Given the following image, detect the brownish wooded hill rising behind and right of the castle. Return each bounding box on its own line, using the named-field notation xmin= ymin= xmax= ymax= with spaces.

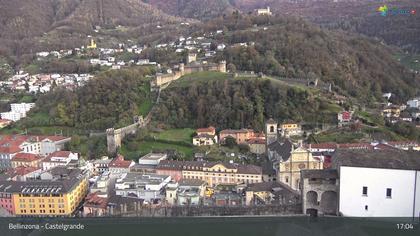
xmin=204 ymin=14 xmax=420 ymax=102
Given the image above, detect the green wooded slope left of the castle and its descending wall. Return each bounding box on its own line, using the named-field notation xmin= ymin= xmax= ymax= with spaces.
xmin=19 ymin=69 xmax=151 ymax=130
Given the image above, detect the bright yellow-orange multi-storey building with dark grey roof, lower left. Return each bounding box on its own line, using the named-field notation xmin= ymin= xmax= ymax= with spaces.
xmin=12 ymin=167 xmax=88 ymax=216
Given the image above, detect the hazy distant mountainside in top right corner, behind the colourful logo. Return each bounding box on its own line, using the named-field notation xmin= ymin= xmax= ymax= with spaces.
xmin=232 ymin=0 xmax=420 ymax=52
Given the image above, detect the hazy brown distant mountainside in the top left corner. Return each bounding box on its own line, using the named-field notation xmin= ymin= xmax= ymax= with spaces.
xmin=0 ymin=0 xmax=181 ymax=58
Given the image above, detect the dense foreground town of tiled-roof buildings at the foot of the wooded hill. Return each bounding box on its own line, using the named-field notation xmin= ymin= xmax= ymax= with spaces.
xmin=0 ymin=113 xmax=420 ymax=217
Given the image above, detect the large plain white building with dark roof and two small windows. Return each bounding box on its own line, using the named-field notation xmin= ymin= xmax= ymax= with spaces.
xmin=333 ymin=150 xmax=420 ymax=217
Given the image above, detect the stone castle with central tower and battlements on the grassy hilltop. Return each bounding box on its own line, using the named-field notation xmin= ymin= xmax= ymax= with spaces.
xmin=152 ymin=53 xmax=226 ymax=87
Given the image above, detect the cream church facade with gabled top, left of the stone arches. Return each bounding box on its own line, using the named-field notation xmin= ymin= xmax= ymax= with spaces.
xmin=279 ymin=147 xmax=323 ymax=190
